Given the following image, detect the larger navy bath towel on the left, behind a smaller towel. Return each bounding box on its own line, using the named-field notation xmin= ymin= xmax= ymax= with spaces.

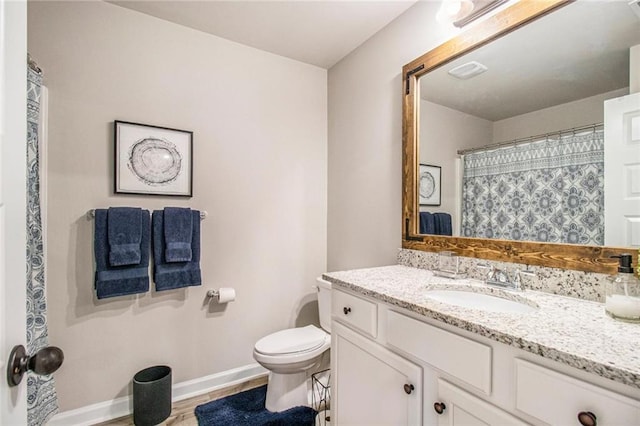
xmin=93 ymin=209 xmax=151 ymax=299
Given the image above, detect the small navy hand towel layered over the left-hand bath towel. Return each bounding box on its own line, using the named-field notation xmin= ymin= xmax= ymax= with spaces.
xmin=107 ymin=207 xmax=142 ymax=266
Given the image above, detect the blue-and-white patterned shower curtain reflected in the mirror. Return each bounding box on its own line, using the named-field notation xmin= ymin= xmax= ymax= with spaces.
xmin=462 ymin=129 xmax=604 ymax=245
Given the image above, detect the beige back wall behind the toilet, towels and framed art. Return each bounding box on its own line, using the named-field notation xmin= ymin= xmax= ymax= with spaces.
xmin=28 ymin=2 xmax=327 ymax=411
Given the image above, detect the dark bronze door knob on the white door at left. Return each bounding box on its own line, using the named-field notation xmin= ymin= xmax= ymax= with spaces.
xmin=7 ymin=345 xmax=64 ymax=386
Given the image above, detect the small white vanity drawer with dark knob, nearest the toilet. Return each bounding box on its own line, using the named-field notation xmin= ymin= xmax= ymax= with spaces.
xmin=331 ymin=290 xmax=378 ymax=337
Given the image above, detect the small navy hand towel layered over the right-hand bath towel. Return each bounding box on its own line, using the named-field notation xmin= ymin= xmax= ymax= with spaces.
xmin=164 ymin=207 xmax=192 ymax=262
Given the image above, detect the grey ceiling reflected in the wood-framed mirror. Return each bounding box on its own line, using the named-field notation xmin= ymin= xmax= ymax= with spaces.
xmin=420 ymin=1 xmax=640 ymax=121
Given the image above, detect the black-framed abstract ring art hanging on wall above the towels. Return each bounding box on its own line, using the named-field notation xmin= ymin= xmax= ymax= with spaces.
xmin=113 ymin=120 xmax=193 ymax=197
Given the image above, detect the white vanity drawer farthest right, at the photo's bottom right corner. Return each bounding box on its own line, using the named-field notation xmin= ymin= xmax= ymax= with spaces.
xmin=515 ymin=359 xmax=640 ymax=426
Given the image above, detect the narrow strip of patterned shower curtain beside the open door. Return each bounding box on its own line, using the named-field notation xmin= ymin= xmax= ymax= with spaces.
xmin=26 ymin=58 xmax=58 ymax=425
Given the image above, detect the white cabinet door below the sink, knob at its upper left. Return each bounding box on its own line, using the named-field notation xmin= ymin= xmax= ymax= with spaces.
xmin=434 ymin=379 xmax=527 ymax=426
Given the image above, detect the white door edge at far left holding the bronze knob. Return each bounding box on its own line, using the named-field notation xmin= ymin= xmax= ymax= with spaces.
xmin=0 ymin=0 xmax=27 ymax=425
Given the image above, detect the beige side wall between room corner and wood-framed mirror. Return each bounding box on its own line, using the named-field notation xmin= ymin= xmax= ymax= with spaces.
xmin=327 ymin=2 xmax=458 ymax=271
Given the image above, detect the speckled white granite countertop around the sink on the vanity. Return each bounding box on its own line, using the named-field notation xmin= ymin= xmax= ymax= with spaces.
xmin=323 ymin=265 xmax=640 ymax=388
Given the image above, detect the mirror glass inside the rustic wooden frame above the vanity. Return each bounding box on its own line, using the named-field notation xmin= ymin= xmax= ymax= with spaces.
xmin=418 ymin=2 xmax=640 ymax=247
